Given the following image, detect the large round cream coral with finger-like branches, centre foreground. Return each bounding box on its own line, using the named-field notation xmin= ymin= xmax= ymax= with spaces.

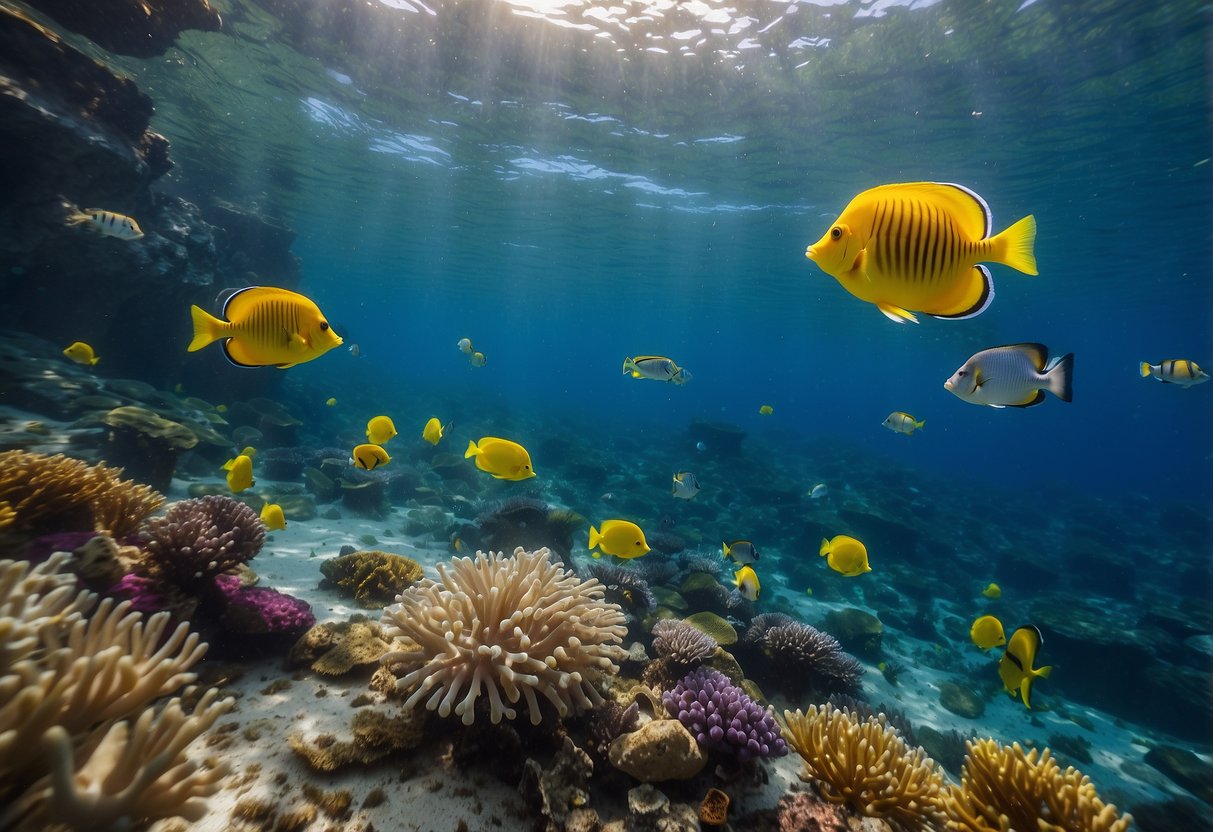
xmin=381 ymin=547 xmax=627 ymax=725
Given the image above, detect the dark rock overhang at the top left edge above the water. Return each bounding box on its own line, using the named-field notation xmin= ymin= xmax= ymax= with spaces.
xmin=29 ymin=0 xmax=222 ymax=58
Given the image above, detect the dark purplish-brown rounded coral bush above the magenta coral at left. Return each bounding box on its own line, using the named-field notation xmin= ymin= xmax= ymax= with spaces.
xmin=141 ymin=495 xmax=266 ymax=594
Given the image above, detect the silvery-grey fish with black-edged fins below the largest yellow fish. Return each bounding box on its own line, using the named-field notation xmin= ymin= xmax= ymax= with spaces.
xmin=944 ymin=343 xmax=1074 ymax=408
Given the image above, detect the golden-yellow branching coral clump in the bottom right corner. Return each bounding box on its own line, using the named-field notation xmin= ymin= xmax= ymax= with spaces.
xmin=939 ymin=739 xmax=1133 ymax=832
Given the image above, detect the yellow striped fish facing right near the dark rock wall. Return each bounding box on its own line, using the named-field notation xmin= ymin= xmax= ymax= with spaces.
xmin=189 ymin=286 xmax=341 ymax=369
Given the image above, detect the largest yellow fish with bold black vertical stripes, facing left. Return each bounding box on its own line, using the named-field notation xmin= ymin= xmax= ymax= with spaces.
xmin=804 ymin=182 xmax=1036 ymax=324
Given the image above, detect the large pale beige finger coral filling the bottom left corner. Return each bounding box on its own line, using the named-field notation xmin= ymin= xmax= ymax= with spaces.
xmin=0 ymin=553 xmax=234 ymax=831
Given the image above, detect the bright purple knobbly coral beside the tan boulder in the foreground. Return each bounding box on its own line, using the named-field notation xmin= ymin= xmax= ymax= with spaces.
xmin=661 ymin=667 xmax=787 ymax=762
